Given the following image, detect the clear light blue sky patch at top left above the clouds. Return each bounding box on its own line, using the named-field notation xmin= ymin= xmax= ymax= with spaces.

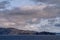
xmin=1 ymin=0 xmax=35 ymax=8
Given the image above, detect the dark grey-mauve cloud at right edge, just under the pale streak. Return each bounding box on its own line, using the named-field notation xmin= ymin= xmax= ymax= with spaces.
xmin=43 ymin=7 xmax=60 ymax=16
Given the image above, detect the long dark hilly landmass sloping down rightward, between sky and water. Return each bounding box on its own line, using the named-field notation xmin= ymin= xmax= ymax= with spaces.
xmin=0 ymin=28 xmax=56 ymax=35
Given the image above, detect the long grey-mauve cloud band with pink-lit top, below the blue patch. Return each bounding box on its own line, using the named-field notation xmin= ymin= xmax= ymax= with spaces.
xmin=4 ymin=5 xmax=60 ymax=18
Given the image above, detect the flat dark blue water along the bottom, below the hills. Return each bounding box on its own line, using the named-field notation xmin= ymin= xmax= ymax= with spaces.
xmin=0 ymin=35 xmax=60 ymax=40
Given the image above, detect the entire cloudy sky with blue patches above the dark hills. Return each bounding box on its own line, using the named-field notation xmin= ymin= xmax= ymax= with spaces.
xmin=0 ymin=0 xmax=60 ymax=33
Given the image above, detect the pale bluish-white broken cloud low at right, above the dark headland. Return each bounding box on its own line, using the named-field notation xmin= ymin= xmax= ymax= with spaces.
xmin=26 ymin=17 xmax=60 ymax=33
